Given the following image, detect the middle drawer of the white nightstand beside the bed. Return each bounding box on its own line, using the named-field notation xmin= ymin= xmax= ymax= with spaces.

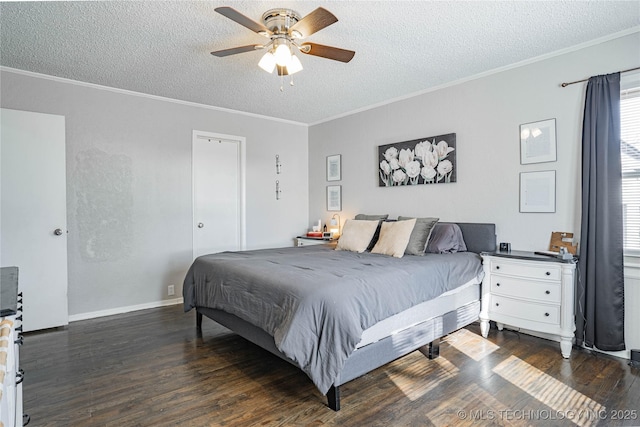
xmin=491 ymin=275 xmax=562 ymax=304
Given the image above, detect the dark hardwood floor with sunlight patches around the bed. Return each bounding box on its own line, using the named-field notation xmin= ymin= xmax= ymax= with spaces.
xmin=21 ymin=306 xmax=640 ymax=427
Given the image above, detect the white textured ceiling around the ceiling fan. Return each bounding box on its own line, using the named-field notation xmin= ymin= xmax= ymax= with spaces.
xmin=0 ymin=0 xmax=640 ymax=123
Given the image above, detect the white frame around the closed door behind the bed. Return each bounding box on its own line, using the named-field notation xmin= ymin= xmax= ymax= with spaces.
xmin=191 ymin=130 xmax=247 ymax=258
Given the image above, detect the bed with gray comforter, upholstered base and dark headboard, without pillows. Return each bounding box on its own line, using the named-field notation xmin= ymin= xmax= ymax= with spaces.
xmin=183 ymin=223 xmax=496 ymax=411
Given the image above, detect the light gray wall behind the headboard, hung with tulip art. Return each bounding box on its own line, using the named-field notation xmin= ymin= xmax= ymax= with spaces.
xmin=309 ymin=33 xmax=640 ymax=358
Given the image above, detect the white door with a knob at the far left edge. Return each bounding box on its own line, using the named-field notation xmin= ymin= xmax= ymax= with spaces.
xmin=0 ymin=108 xmax=69 ymax=331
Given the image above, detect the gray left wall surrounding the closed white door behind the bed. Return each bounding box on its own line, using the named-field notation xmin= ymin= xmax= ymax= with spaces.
xmin=0 ymin=70 xmax=309 ymax=318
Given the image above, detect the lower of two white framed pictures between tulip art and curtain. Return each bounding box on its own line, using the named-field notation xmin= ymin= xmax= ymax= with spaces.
xmin=520 ymin=171 xmax=556 ymax=212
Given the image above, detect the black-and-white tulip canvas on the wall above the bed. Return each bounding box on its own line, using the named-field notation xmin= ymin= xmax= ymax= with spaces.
xmin=378 ymin=133 xmax=456 ymax=187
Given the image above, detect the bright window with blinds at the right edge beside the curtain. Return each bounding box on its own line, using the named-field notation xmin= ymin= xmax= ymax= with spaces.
xmin=620 ymin=87 xmax=640 ymax=255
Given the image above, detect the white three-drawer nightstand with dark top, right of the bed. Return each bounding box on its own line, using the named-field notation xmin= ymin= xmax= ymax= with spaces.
xmin=480 ymin=251 xmax=576 ymax=358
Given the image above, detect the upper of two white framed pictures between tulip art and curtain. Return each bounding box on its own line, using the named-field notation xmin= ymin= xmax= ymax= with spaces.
xmin=520 ymin=119 xmax=556 ymax=165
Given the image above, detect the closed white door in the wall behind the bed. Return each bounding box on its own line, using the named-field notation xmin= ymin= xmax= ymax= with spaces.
xmin=192 ymin=131 xmax=244 ymax=258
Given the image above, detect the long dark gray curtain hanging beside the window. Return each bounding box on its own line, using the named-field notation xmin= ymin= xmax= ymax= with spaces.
xmin=576 ymin=73 xmax=625 ymax=351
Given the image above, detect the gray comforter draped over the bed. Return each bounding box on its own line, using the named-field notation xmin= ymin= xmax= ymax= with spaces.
xmin=183 ymin=245 xmax=482 ymax=394
